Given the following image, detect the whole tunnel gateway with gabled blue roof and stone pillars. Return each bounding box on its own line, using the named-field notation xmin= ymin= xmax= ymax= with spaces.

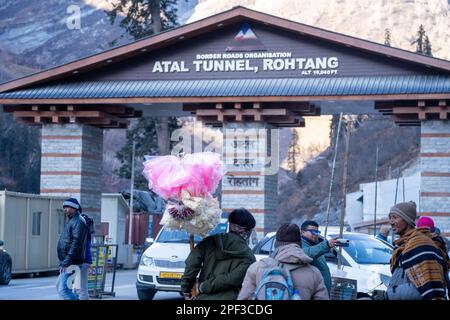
xmin=0 ymin=3 xmax=450 ymax=260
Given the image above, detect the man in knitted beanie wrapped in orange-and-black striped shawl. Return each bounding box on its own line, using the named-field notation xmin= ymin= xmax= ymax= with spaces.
xmin=374 ymin=201 xmax=448 ymax=300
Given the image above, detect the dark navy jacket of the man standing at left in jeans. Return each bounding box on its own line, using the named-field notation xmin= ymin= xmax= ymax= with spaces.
xmin=57 ymin=211 xmax=87 ymax=267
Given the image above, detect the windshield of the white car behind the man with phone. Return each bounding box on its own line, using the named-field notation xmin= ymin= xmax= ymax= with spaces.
xmin=330 ymin=234 xmax=392 ymax=264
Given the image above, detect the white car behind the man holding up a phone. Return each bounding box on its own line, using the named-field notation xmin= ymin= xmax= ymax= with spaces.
xmin=253 ymin=232 xmax=392 ymax=297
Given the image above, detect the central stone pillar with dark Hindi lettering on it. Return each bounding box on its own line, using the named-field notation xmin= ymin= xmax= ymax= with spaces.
xmin=221 ymin=123 xmax=279 ymax=240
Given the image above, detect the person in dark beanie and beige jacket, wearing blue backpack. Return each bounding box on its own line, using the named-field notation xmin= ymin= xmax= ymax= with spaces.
xmin=238 ymin=223 xmax=329 ymax=300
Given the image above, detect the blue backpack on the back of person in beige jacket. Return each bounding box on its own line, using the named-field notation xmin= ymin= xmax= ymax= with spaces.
xmin=253 ymin=258 xmax=300 ymax=300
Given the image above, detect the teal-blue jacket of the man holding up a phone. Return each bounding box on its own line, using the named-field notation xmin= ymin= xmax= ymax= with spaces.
xmin=302 ymin=237 xmax=331 ymax=293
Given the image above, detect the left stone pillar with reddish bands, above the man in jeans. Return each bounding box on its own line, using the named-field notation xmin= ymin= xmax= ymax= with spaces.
xmin=41 ymin=124 xmax=103 ymax=233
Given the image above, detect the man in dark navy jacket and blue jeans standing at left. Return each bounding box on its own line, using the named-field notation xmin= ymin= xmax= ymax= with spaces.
xmin=57 ymin=198 xmax=88 ymax=300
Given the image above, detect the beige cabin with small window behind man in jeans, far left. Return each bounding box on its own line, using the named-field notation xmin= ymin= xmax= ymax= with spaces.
xmin=0 ymin=190 xmax=66 ymax=274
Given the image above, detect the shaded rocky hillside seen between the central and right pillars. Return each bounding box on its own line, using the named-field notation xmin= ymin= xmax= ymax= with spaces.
xmin=279 ymin=116 xmax=420 ymax=223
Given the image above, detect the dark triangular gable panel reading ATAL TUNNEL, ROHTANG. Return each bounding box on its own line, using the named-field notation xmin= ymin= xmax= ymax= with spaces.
xmin=88 ymin=22 xmax=422 ymax=81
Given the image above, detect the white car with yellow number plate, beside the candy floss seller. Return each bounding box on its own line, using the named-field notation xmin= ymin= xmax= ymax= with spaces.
xmin=136 ymin=219 xmax=256 ymax=300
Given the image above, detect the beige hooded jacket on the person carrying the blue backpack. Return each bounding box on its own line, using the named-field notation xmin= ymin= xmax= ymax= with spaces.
xmin=238 ymin=243 xmax=329 ymax=300
